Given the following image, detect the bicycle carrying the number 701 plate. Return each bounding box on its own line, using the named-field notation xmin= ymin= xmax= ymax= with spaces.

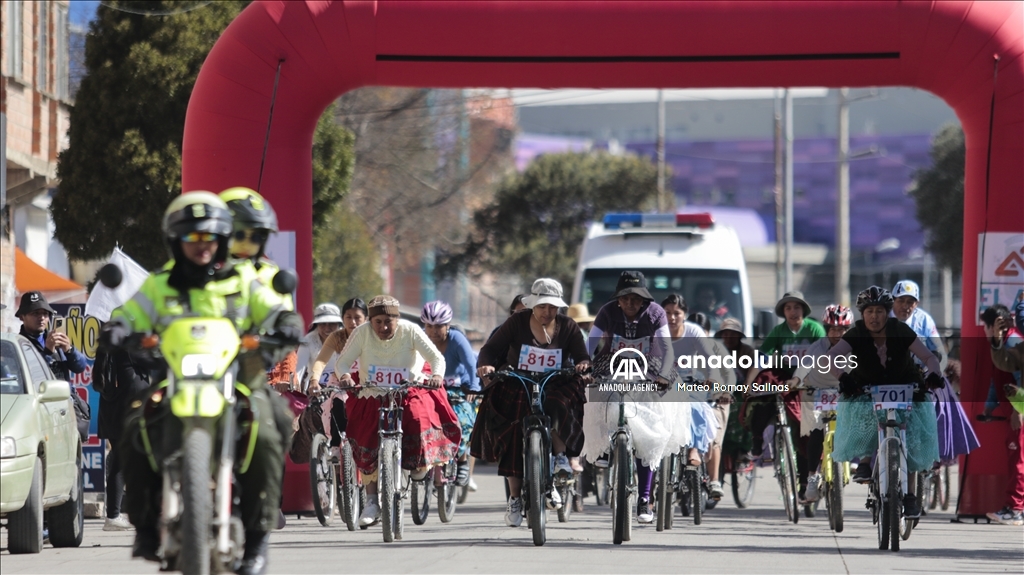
xmin=866 ymin=385 xmax=915 ymax=551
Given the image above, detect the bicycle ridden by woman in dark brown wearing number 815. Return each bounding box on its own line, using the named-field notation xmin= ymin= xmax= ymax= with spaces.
xmin=490 ymin=367 xmax=578 ymax=546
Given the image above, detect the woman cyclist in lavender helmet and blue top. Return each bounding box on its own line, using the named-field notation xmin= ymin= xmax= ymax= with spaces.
xmin=420 ymin=301 xmax=480 ymax=487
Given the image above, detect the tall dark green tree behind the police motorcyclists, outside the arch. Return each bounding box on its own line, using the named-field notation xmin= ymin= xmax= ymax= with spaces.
xmin=51 ymin=1 xmax=247 ymax=268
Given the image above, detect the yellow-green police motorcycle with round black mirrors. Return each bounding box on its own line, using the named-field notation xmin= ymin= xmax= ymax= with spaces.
xmin=99 ymin=264 xmax=297 ymax=574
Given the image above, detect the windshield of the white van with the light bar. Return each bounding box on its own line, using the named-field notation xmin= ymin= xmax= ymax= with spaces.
xmin=580 ymin=268 xmax=745 ymax=335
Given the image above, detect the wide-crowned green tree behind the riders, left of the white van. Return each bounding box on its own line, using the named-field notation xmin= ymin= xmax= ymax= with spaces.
xmin=437 ymin=153 xmax=657 ymax=292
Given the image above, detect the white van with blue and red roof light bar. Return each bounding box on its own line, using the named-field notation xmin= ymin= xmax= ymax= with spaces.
xmin=572 ymin=214 xmax=754 ymax=337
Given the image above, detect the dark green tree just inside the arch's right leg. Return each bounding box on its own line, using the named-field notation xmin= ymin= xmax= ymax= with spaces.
xmin=910 ymin=124 xmax=967 ymax=274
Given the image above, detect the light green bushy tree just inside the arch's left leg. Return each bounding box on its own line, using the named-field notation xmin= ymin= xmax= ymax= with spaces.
xmin=313 ymin=203 xmax=383 ymax=306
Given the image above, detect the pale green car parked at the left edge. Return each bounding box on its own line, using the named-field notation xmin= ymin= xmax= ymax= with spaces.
xmin=0 ymin=334 xmax=84 ymax=554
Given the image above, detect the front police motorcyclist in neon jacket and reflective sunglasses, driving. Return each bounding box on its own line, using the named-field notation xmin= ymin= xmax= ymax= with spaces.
xmin=100 ymin=191 xmax=302 ymax=573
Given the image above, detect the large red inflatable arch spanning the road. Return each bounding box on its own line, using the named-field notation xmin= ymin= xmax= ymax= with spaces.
xmin=182 ymin=1 xmax=1024 ymax=515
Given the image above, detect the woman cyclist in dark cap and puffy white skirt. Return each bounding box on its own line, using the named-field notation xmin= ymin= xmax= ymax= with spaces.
xmin=584 ymin=271 xmax=682 ymax=523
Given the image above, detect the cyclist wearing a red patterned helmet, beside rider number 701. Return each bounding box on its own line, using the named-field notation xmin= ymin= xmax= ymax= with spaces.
xmin=787 ymin=304 xmax=866 ymax=503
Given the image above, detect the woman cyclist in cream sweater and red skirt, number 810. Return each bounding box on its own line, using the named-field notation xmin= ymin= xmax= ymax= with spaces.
xmin=335 ymin=296 xmax=462 ymax=525
